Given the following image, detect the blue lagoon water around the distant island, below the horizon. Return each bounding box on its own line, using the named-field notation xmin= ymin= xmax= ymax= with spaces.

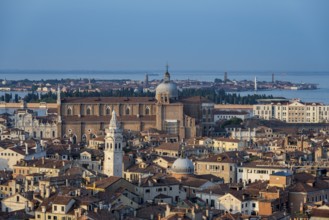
xmin=0 ymin=70 xmax=329 ymax=104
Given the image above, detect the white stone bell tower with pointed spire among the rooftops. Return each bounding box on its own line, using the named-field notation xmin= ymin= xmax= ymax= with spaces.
xmin=103 ymin=110 xmax=123 ymax=177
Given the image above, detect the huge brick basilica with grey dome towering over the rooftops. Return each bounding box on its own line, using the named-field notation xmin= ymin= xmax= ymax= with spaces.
xmin=57 ymin=71 xmax=214 ymax=142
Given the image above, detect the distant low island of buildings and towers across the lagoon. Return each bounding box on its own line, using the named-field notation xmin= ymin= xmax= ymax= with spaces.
xmin=0 ymin=73 xmax=318 ymax=93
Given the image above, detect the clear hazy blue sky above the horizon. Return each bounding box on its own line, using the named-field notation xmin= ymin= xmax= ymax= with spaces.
xmin=0 ymin=0 xmax=329 ymax=71
